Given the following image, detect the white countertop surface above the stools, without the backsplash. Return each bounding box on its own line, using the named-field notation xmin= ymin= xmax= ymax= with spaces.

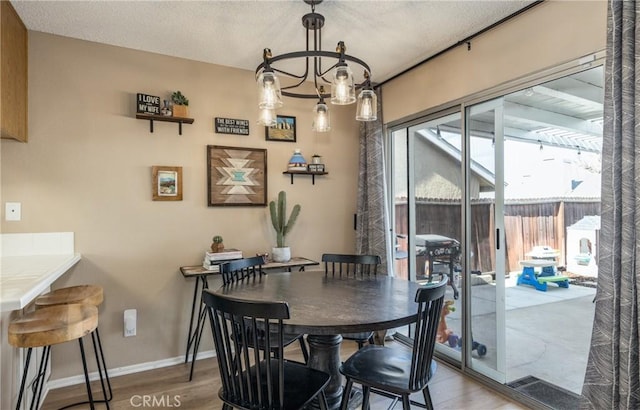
xmin=0 ymin=253 xmax=81 ymax=312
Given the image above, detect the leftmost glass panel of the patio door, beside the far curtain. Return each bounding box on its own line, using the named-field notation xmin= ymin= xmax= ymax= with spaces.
xmin=392 ymin=112 xmax=463 ymax=361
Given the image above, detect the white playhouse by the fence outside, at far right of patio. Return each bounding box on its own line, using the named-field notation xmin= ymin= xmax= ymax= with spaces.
xmin=567 ymin=215 xmax=600 ymax=277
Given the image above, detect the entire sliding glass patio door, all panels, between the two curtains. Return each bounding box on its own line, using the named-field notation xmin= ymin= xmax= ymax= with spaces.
xmin=388 ymin=66 xmax=603 ymax=407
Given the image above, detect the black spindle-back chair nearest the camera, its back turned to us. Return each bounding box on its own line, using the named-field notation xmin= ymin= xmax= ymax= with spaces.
xmin=202 ymin=289 xmax=331 ymax=410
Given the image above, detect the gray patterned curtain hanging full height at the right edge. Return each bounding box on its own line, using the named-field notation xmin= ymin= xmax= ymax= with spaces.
xmin=582 ymin=0 xmax=640 ymax=409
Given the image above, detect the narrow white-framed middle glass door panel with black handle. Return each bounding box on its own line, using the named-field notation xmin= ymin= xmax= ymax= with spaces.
xmin=465 ymin=98 xmax=506 ymax=383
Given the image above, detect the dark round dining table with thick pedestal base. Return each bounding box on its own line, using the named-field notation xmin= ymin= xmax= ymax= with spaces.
xmin=216 ymin=271 xmax=420 ymax=409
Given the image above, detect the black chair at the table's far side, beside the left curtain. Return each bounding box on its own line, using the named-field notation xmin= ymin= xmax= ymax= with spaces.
xmin=322 ymin=253 xmax=381 ymax=349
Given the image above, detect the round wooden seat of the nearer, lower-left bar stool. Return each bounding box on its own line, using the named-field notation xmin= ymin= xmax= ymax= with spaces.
xmin=8 ymin=304 xmax=98 ymax=347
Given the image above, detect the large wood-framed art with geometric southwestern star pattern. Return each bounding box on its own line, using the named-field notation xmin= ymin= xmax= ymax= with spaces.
xmin=207 ymin=145 xmax=267 ymax=206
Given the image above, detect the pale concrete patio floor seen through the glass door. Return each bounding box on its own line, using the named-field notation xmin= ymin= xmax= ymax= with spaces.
xmin=436 ymin=275 xmax=596 ymax=394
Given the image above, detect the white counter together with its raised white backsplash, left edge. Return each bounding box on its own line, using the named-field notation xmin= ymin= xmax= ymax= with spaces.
xmin=0 ymin=232 xmax=81 ymax=312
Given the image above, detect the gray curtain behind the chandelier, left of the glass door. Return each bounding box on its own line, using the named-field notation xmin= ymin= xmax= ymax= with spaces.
xmin=356 ymin=90 xmax=393 ymax=274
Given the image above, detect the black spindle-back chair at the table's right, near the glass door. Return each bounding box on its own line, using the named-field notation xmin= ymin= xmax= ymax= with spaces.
xmin=340 ymin=280 xmax=447 ymax=410
